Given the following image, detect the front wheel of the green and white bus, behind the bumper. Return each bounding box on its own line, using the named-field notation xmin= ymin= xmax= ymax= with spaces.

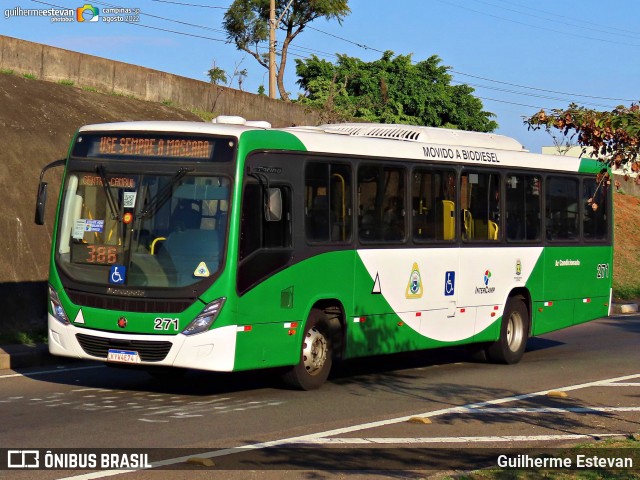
xmin=282 ymin=309 xmax=333 ymax=390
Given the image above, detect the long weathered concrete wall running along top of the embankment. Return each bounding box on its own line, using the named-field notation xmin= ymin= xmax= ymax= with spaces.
xmin=0 ymin=35 xmax=320 ymax=127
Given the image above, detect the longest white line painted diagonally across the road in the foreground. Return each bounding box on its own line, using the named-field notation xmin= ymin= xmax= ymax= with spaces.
xmin=55 ymin=373 xmax=640 ymax=480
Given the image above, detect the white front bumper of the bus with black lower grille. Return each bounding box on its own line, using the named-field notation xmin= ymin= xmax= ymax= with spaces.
xmin=48 ymin=314 xmax=237 ymax=372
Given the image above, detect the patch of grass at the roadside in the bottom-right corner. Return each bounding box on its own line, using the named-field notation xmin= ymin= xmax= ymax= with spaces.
xmin=450 ymin=434 xmax=640 ymax=480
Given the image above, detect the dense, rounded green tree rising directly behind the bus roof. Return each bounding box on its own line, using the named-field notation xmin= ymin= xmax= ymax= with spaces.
xmin=296 ymin=51 xmax=498 ymax=132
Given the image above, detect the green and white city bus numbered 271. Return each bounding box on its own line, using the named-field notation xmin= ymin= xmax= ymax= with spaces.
xmin=36 ymin=117 xmax=613 ymax=389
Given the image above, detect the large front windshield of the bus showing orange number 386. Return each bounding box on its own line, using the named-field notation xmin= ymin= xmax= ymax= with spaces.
xmin=56 ymin=170 xmax=230 ymax=288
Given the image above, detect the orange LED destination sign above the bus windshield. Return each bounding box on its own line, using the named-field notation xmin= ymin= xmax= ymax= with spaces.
xmin=72 ymin=132 xmax=237 ymax=162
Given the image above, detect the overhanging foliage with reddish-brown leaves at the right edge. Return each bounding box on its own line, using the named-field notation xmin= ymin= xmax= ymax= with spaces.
xmin=524 ymin=103 xmax=640 ymax=179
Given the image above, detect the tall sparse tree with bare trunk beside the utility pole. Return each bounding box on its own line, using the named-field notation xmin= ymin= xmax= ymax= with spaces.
xmin=223 ymin=0 xmax=351 ymax=101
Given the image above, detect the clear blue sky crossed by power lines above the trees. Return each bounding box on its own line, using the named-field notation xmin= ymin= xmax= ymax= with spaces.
xmin=0 ymin=0 xmax=640 ymax=153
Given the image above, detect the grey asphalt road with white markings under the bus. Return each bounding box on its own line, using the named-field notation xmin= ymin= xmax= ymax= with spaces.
xmin=0 ymin=315 xmax=640 ymax=480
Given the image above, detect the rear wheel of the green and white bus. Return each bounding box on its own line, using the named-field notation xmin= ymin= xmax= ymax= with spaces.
xmin=486 ymin=296 xmax=530 ymax=364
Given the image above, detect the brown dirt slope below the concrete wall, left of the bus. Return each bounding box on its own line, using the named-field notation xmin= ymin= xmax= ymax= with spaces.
xmin=0 ymin=74 xmax=200 ymax=333
